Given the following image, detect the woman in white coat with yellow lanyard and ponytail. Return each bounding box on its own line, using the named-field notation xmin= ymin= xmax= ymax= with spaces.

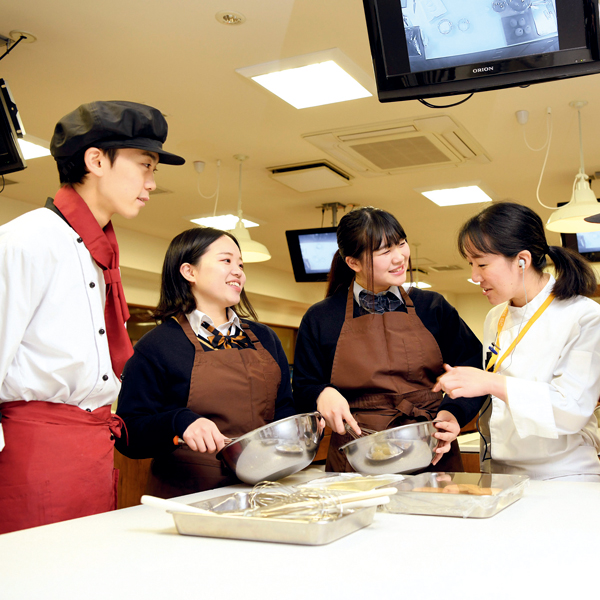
xmin=434 ymin=202 xmax=600 ymax=482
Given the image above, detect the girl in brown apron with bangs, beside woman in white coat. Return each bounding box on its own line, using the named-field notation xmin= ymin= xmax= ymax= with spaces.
xmin=294 ymin=207 xmax=483 ymax=472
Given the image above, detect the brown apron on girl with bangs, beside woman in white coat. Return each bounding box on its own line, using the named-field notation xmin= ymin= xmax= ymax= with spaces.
xmin=326 ymin=283 xmax=463 ymax=473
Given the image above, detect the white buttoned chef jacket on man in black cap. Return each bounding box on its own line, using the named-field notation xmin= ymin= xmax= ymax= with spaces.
xmin=0 ymin=208 xmax=120 ymax=411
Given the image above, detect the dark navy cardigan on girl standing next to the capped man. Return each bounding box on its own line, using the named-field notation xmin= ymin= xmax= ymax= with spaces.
xmin=115 ymin=319 xmax=296 ymax=458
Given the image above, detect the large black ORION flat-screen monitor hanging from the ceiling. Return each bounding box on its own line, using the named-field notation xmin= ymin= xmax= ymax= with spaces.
xmin=363 ymin=0 xmax=600 ymax=102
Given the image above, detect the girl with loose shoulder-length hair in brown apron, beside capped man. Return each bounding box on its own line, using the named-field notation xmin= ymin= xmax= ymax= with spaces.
xmin=117 ymin=228 xmax=295 ymax=498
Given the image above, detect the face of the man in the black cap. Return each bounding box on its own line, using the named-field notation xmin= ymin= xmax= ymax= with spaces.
xmin=90 ymin=148 xmax=158 ymax=222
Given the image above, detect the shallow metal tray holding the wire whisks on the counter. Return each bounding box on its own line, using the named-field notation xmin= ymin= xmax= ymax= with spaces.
xmin=169 ymin=492 xmax=377 ymax=546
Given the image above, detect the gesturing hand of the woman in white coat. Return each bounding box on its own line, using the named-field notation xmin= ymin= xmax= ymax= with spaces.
xmin=433 ymin=365 xmax=506 ymax=401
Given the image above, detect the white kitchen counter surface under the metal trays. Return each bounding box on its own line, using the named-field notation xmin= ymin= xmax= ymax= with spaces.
xmin=0 ymin=474 xmax=600 ymax=600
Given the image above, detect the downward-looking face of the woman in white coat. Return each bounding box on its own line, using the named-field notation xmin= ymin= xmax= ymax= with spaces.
xmin=465 ymin=252 xmax=525 ymax=306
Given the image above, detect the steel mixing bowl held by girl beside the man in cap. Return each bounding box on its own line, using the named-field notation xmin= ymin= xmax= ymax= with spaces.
xmin=217 ymin=412 xmax=323 ymax=485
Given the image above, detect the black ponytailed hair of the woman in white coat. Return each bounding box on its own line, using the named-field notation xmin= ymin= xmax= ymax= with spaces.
xmin=458 ymin=202 xmax=597 ymax=300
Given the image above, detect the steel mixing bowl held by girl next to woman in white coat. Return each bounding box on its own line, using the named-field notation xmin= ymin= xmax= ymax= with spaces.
xmin=340 ymin=421 xmax=437 ymax=475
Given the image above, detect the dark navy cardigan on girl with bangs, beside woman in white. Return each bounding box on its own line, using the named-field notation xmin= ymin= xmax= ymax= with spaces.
xmin=293 ymin=288 xmax=485 ymax=427
